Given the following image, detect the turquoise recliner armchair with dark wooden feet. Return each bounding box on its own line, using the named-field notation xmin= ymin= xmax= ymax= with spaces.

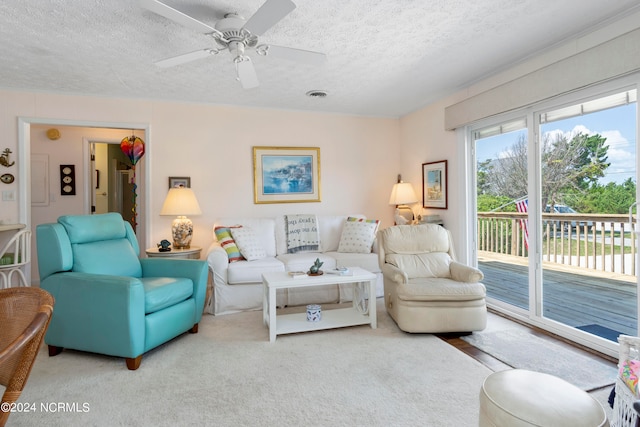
xmin=36 ymin=213 xmax=208 ymax=370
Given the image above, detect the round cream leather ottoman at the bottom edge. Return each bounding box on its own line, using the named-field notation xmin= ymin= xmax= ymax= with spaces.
xmin=480 ymin=369 xmax=609 ymax=427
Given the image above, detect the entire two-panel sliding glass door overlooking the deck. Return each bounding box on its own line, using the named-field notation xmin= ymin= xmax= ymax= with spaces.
xmin=468 ymin=83 xmax=640 ymax=352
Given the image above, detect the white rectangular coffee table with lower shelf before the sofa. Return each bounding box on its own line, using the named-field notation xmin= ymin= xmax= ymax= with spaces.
xmin=262 ymin=267 xmax=377 ymax=342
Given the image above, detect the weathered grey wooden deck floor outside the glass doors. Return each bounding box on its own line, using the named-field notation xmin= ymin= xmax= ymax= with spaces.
xmin=478 ymin=256 xmax=638 ymax=340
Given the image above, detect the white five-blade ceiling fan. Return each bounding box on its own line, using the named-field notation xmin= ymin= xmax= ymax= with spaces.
xmin=140 ymin=0 xmax=327 ymax=89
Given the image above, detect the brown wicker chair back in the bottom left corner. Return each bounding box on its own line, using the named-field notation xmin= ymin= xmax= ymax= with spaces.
xmin=0 ymin=287 xmax=54 ymax=427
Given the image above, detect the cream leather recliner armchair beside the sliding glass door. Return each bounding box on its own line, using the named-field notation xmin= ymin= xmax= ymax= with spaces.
xmin=378 ymin=224 xmax=487 ymax=333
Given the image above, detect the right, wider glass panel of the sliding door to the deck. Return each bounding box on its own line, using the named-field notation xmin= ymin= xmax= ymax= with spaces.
xmin=537 ymin=90 xmax=638 ymax=342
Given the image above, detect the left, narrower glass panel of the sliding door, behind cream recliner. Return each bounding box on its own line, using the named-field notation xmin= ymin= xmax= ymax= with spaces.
xmin=473 ymin=118 xmax=529 ymax=311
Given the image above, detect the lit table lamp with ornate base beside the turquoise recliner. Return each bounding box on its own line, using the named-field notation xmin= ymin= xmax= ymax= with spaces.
xmin=160 ymin=187 xmax=202 ymax=249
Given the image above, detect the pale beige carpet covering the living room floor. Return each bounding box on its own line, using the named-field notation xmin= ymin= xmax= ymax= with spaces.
xmin=8 ymin=301 xmax=491 ymax=427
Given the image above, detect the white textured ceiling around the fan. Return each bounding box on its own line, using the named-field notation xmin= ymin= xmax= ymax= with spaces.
xmin=0 ymin=0 xmax=639 ymax=117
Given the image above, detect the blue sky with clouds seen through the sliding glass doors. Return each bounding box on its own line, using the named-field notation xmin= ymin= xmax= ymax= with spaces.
xmin=476 ymin=103 xmax=637 ymax=184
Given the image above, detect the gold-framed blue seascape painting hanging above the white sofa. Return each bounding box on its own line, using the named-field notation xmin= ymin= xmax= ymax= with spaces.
xmin=253 ymin=147 xmax=320 ymax=203
